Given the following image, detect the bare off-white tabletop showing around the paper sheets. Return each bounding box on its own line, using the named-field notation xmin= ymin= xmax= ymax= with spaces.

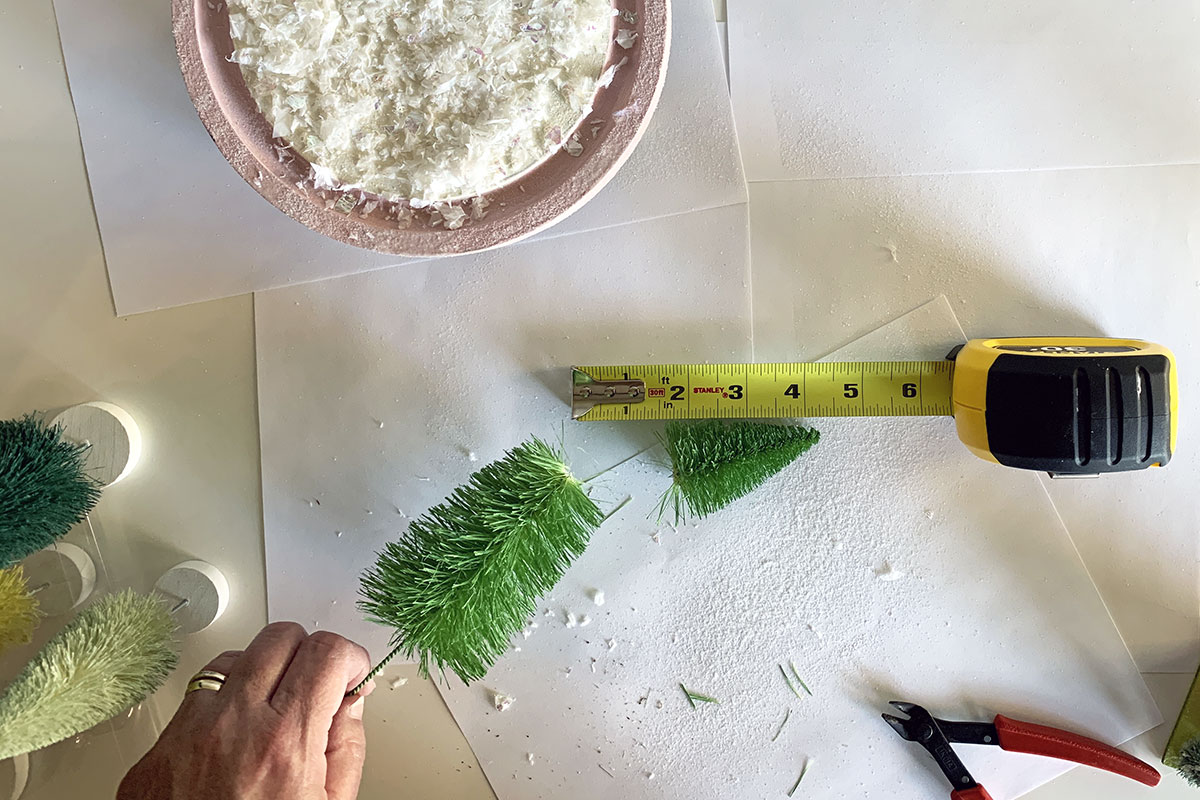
xmin=0 ymin=0 xmax=1195 ymax=800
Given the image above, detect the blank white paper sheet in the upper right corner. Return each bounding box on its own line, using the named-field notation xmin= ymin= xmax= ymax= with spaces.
xmin=728 ymin=0 xmax=1200 ymax=181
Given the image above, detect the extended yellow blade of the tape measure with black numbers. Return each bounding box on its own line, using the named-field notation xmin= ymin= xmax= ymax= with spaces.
xmin=571 ymin=361 xmax=954 ymax=421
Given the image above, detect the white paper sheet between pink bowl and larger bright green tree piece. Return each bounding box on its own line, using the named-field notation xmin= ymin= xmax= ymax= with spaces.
xmin=254 ymin=205 xmax=750 ymax=658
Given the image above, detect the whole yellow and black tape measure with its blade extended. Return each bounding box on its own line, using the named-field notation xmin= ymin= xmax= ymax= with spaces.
xmin=571 ymin=337 xmax=1178 ymax=476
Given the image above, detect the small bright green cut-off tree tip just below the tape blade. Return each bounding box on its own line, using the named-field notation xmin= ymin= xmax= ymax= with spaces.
xmin=659 ymin=420 xmax=821 ymax=522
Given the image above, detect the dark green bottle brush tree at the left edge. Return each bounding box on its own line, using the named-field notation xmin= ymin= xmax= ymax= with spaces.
xmin=0 ymin=415 xmax=101 ymax=567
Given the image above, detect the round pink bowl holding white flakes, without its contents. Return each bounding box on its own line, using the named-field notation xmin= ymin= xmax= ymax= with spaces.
xmin=172 ymin=0 xmax=671 ymax=255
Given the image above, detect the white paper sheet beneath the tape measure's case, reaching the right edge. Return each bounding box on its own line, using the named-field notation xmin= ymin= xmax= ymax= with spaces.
xmin=750 ymin=172 xmax=1200 ymax=673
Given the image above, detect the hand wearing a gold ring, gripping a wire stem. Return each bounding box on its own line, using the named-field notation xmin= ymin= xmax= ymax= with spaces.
xmin=116 ymin=622 xmax=374 ymax=800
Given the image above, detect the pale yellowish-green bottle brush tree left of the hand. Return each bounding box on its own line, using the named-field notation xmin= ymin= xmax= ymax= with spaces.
xmin=0 ymin=590 xmax=178 ymax=760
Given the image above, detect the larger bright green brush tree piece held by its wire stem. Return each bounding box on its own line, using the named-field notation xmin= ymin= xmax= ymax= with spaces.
xmin=359 ymin=439 xmax=604 ymax=682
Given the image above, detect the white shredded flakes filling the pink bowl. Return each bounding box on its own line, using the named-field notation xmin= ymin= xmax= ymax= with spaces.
xmin=229 ymin=0 xmax=625 ymax=203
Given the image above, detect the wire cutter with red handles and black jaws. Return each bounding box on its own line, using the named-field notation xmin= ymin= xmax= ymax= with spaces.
xmin=883 ymin=700 xmax=1160 ymax=800
